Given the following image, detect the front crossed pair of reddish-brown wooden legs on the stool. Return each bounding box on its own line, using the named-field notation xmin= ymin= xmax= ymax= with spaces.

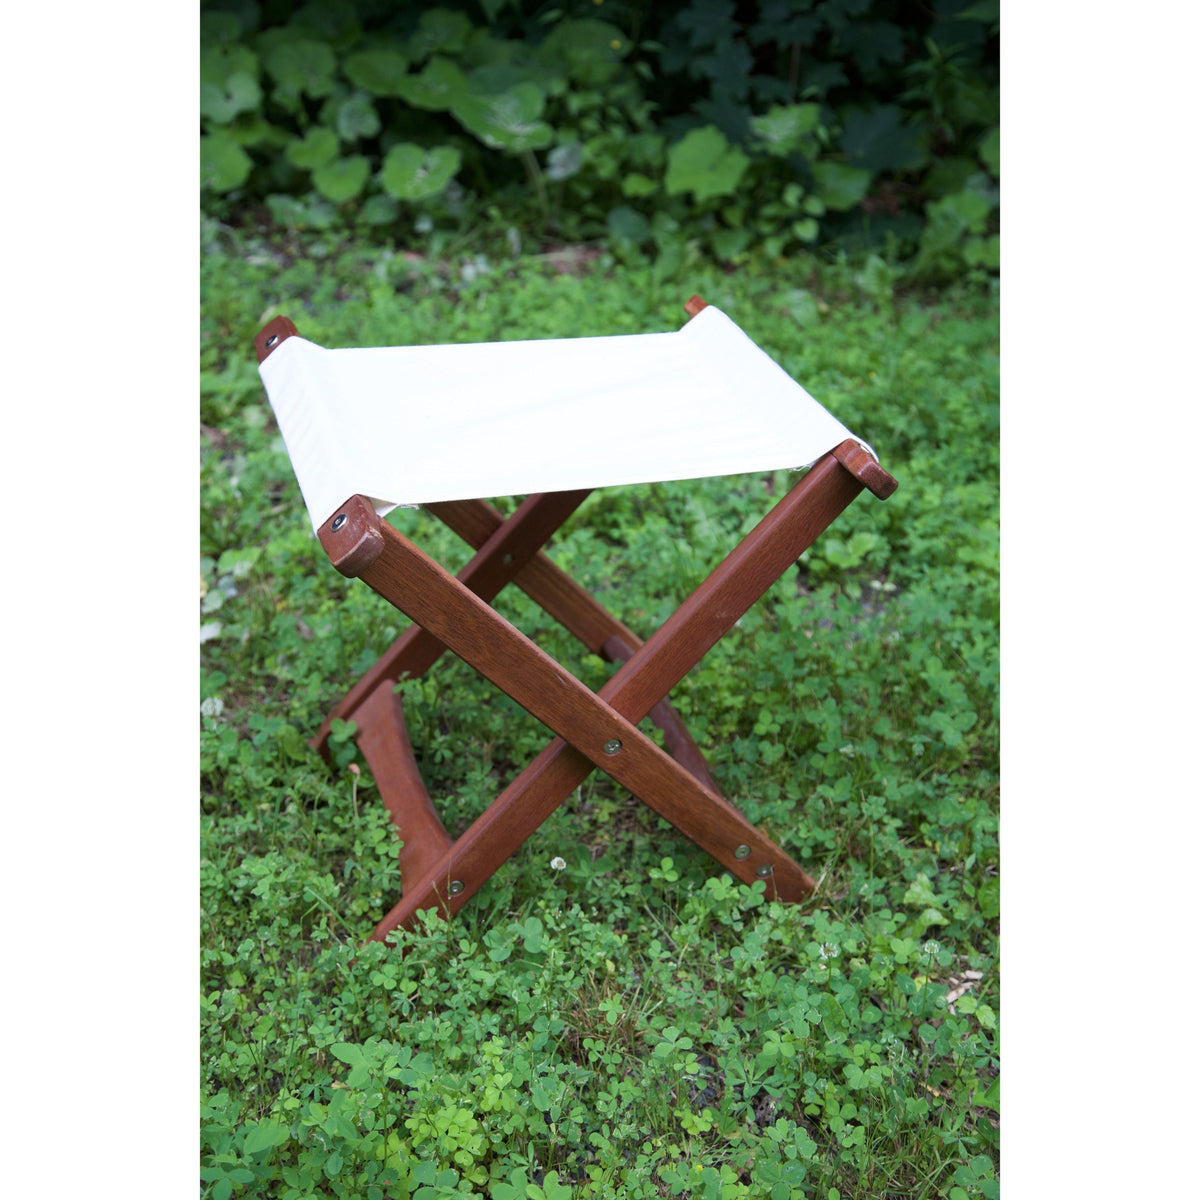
xmin=320 ymin=456 xmax=878 ymax=936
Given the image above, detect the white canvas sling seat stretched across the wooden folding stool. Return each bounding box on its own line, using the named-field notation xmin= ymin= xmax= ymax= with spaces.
xmin=260 ymin=306 xmax=868 ymax=529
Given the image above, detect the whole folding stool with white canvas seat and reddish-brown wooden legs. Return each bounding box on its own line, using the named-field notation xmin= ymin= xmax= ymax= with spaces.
xmin=254 ymin=296 xmax=896 ymax=940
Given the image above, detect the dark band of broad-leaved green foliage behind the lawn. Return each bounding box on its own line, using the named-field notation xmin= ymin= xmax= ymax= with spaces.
xmin=200 ymin=0 xmax=1000 ymax=283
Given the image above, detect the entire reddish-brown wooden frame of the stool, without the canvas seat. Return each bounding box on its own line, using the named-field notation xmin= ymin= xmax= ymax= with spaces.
xmin=254 ymin=298 xmax=896 ymax=940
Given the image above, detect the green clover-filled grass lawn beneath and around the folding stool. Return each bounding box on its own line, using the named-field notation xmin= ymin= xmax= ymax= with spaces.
xmin=200 ymin=226 xmax=1000 ymax=1200
